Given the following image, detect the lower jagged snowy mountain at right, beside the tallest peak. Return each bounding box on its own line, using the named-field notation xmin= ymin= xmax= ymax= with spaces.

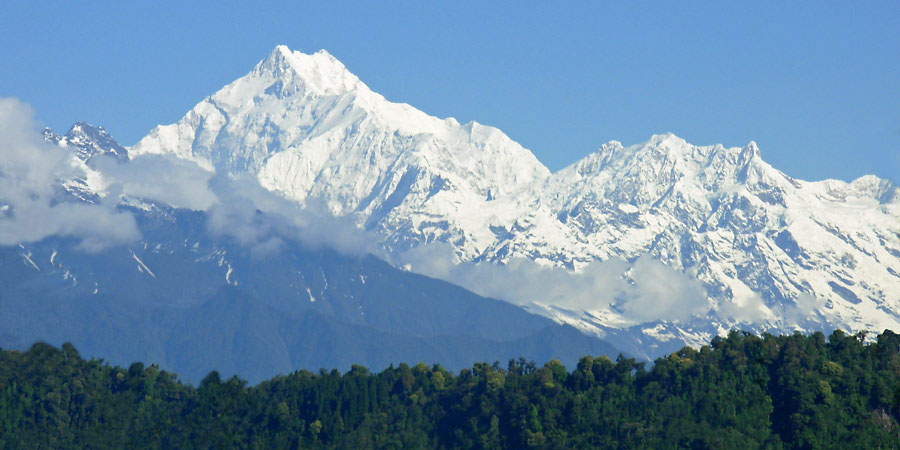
xmin=510 ymin=134 xmax=900 ymax=356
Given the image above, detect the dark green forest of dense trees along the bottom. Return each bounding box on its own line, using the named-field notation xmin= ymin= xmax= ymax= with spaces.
xmin=0 ymin=331 xmax=900 ymax=449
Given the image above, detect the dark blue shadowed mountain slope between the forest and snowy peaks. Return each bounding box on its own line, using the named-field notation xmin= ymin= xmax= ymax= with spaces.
xmin=0 ymin=208 xmax=618 ymax=382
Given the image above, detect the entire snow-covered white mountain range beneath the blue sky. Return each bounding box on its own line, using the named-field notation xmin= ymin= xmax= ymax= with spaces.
xmin=128 ymin=46 xmax=900 ymax=356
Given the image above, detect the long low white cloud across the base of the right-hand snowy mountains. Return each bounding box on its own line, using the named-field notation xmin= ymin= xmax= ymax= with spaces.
xmin=395 ymin=244 xmax=710 ymax=323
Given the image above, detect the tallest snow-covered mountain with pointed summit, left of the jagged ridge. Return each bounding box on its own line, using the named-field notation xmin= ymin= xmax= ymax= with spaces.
xmin=129 ymin=46 xmax=549 ymax=259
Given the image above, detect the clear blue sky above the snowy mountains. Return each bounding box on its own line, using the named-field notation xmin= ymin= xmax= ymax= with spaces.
xmin=0 ymin=0 xmax=900 ymax=181
